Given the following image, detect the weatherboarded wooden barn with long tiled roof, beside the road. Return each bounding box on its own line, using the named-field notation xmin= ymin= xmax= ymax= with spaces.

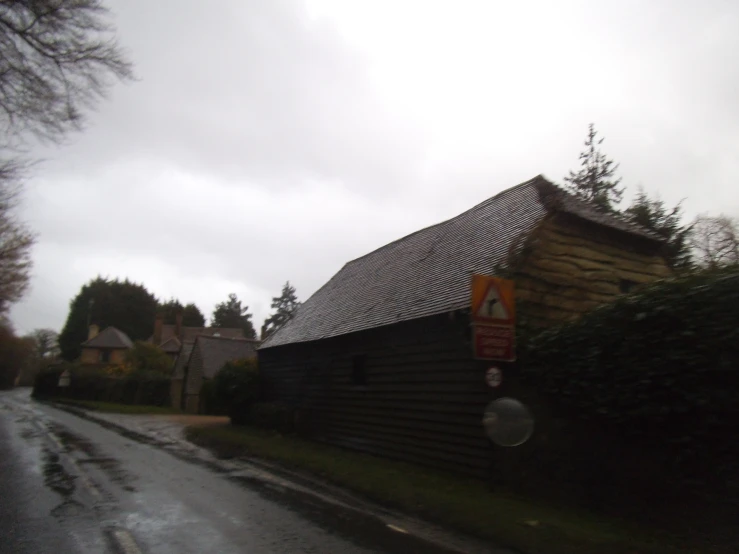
xmin=259 ymin=176 xmax=670 ymax=476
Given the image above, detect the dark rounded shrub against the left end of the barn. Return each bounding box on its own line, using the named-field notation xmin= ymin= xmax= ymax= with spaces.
xmin=213 ymin=360 xmax=260 ymax=425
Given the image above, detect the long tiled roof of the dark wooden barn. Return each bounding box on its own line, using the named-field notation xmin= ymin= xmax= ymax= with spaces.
xmin=261 ymin=176 xmax=661 ymax=349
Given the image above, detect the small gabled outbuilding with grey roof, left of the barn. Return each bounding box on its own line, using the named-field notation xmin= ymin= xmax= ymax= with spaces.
xmin=175 ymin=335 xmax=259 ymax=413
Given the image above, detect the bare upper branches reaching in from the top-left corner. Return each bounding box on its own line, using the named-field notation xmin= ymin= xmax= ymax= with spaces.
xmin=0 ymin=0 xmax=132 ymax=144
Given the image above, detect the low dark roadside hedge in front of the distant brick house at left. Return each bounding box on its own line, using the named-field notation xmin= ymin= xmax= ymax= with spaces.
xmin=33 ymin=364 xmax=170 ymax=406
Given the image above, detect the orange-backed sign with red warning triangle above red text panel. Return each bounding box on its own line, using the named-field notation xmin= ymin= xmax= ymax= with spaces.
xmin=471 ymin=275 xmax=516 ymax=362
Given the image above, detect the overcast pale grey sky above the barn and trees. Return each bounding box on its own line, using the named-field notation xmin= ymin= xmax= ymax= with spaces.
xmin=7 ymin=0 xmax=739 ymax=333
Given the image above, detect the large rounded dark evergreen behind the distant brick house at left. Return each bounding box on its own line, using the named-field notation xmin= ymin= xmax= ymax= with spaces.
xmin=59 ymin=277 xmax=158 ymax=361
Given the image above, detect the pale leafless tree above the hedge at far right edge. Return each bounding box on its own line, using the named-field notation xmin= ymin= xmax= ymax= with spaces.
xmin=691 ymin=214 xmax=739 ymax=269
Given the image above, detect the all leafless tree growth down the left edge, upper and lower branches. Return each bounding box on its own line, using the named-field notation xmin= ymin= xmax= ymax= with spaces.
xmin=0 ymin=0 xmax=132 ymax=315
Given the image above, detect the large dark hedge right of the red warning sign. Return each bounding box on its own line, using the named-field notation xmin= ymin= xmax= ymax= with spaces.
xmin=520 ymin=272 xmax=739 ymax=477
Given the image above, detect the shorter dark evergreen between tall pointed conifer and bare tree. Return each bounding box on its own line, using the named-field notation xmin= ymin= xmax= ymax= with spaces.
xmin=624 ymin=189 xmax=693 ymax=271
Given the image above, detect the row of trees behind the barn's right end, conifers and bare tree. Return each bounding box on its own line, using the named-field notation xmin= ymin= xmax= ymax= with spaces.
xmin=564 ymin=123 xmax=739 ymax=272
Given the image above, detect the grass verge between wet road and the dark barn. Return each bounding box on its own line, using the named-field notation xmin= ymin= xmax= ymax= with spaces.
xmin=186 ymin=425 xmax=696 ymax=554
